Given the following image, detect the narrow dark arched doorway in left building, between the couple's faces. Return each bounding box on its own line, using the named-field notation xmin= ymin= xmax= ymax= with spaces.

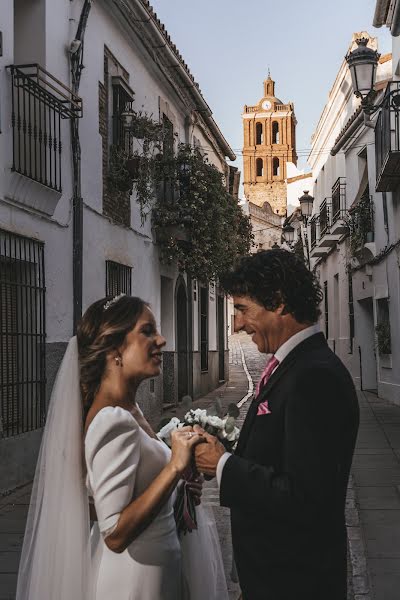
xmin=175 ymin=279 xmax=189 ymax=402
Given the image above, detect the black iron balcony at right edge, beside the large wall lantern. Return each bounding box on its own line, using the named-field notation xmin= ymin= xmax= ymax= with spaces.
xmin=375 ymin=81 xmax=400 ymax=192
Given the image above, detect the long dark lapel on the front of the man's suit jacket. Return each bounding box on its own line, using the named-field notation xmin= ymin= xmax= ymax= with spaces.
xmin=235 ymin=333 xmax=326 ymax=456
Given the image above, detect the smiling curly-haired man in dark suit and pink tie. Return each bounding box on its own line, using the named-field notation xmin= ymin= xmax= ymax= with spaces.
xmin=196 ymin=249 xmax=359 ymax=600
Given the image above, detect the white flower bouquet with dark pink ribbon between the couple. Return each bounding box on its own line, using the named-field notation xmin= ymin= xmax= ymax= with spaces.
xmin=157 ymin=397 xmax=240 ymax=534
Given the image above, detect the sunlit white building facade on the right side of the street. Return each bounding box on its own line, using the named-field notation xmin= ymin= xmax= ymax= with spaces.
xmin=308 ymin=32 xmax=400 ymax=403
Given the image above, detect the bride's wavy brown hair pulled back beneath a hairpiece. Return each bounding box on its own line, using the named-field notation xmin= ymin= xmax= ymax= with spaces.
xmin=76 ymin=296 xmax=148 ymax=415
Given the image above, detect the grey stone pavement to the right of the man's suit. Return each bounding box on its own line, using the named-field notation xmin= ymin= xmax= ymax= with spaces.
xmin=348 ymin=392 xmax=400 ymax=600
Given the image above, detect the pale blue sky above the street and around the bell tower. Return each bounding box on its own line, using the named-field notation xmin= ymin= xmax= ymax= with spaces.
xmin=150 ymin=0 xmax=391 ymax=190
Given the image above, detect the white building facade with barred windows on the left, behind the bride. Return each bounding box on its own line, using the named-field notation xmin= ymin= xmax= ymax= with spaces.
xmin=0 ymin=0 xmax=235 ymax=492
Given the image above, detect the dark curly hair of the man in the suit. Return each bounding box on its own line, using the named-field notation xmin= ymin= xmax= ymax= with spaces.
xmin=220 ymin=248 xmax=323 ymax=324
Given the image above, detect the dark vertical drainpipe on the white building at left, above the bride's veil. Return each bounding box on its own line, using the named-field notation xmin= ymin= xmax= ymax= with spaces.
xmin=69 ymin=0 xmax=92 ymax=333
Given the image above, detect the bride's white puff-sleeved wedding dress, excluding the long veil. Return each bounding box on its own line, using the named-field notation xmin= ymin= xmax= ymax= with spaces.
xmin=85 ymin=407 xmax=228 ymax=600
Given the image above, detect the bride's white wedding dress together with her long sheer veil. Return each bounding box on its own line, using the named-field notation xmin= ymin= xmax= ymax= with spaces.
xmin=16 ymin=337 xmax=228 ymax=600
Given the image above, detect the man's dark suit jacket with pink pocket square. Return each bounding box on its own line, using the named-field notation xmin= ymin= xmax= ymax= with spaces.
xmin=220 ymin=333 xmax=359 ymax=600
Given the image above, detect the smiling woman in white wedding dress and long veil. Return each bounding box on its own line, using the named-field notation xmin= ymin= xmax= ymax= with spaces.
xmin=16 ymin=295 xmax=228 ymax=600
